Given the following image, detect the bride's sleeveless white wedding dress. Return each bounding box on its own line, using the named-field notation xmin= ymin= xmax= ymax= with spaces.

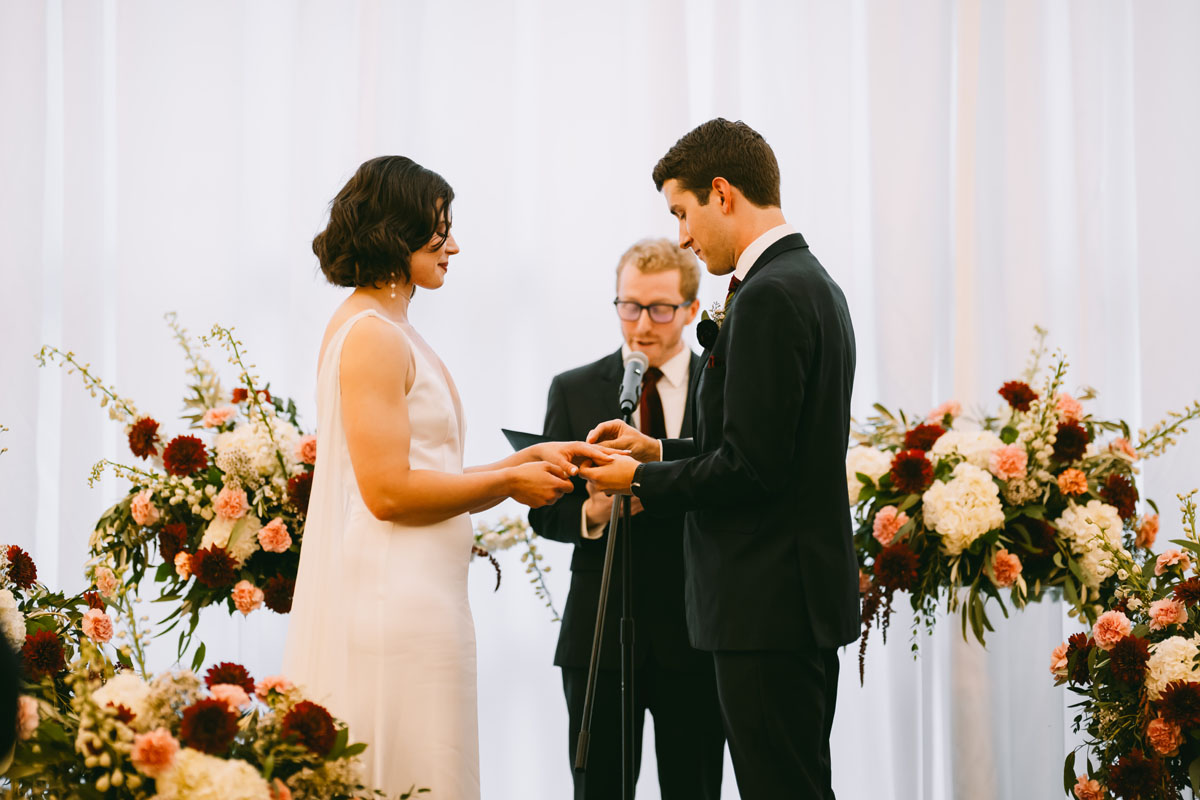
xmin=283 ymin=311 xmax=479 ymax=800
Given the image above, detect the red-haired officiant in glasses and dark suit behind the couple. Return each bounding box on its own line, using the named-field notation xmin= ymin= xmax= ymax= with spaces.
xmin=529 ymin=239 xmax=725 ymax=800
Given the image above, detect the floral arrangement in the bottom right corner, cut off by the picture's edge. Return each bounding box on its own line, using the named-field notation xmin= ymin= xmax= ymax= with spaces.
xmin=1050 ymin=492 xmax=1200 ymax=800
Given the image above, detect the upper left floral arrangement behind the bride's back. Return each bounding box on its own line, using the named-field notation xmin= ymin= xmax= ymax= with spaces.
xmin=37 ymin=314 xmax=317 ymax=661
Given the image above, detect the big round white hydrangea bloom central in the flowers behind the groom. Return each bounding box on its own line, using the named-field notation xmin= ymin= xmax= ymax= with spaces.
xmin=922 ymin=462 xmax=1004 ymax=555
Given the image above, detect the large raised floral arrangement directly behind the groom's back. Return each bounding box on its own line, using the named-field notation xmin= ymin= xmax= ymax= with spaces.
xmin=846 ymin=329 xmax=1200 ymax=679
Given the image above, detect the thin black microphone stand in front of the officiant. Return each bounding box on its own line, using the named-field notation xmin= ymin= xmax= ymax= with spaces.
xmin=575 ymin=410 xmax=641 ymax=800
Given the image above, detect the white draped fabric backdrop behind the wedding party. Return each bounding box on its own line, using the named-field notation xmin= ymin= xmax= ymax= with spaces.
xmin=0 ymin=0 xmax=1200 ymax=800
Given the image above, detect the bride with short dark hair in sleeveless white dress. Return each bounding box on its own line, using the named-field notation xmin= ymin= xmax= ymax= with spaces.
xmin=284 ymin=156 xmax=608 ymax=800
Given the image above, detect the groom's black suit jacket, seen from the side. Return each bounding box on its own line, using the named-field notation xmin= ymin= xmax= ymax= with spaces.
xmin=635 ymin=234 xmax=859 ymax=650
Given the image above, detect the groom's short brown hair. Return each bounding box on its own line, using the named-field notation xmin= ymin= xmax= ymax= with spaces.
xmin=654 ymin=118 xmax=780 ymax=207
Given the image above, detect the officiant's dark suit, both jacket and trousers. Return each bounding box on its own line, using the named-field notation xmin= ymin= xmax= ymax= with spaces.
xmin=529 ymin=261 xmax=725 ymax=800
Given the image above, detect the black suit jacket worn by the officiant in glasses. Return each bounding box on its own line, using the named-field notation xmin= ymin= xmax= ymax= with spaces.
xmin=529 ymin=350 xmax=710 ymax=670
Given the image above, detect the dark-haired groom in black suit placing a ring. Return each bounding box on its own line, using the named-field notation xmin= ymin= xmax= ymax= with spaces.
xmin=581 ymin=119 xmax=859 ymax=800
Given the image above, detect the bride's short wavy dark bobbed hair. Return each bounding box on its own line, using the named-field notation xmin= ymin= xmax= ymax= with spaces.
xmin=312 ymin=156 xmax=454 ymax=287
